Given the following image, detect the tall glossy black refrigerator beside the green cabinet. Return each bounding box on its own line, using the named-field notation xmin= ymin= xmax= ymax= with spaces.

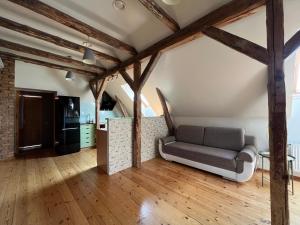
xmin=55 ymin=96 xmax=80 ymax=155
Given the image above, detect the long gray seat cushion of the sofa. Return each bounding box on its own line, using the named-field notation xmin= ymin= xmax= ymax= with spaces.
xmin=163 ymin=142 xmax=238 ymax=172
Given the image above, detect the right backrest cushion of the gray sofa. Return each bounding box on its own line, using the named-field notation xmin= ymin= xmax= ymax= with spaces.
xmin=204 ymin=127 xmax=245 ymax=151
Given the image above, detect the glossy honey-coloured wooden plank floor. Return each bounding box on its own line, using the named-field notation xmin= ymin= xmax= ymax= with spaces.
xmin=0 ymin=150 xmax=300 ymax=225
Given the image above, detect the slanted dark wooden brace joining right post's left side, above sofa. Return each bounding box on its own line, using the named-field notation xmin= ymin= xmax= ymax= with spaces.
xmin=202 ymin=27 xmax=268 ymax=65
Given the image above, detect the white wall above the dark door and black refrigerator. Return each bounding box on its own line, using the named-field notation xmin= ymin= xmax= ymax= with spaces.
xmin=15 ymin=61 xmax=95 ymax=122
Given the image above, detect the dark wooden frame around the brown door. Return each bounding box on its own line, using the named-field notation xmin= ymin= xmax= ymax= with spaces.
xmin=14 ymin=87 xmax=57 ymax=155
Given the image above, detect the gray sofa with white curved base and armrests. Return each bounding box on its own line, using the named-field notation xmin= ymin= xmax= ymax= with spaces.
xmin=159 ymin=126 xmax=257 ymax=182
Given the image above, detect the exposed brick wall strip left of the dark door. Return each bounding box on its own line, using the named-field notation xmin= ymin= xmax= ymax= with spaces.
xmin=0 ymin=58 xmax=16 ymax=160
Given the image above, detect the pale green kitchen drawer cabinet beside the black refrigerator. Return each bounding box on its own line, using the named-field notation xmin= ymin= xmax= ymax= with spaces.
xmin=80 ymin=124 xmax=96 ymax=148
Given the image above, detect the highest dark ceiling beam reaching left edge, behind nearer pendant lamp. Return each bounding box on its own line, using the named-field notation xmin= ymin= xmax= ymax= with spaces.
xmin=0 ymin=17 xmax=120 ymax=64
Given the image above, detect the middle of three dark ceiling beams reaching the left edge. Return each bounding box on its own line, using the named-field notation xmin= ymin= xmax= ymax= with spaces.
xmin=0 ymin=39 xmax=106 ymax=73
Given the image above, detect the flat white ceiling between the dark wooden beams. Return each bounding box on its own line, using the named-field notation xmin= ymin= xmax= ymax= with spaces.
xmin=0 ymin=0 xmax=229 ymax=67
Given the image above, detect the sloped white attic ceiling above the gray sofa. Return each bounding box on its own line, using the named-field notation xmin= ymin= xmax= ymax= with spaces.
xmin=108 ymin=1 xmax=300 ymax=118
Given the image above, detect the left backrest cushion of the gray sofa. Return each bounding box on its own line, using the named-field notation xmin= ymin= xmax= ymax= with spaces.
xmin=176 ymin=125 xmax=204 ymax=145
